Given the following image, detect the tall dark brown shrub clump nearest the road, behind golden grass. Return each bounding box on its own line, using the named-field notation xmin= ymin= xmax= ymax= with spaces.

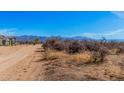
xmin=43 ymin=38 xmax=85 ymax=53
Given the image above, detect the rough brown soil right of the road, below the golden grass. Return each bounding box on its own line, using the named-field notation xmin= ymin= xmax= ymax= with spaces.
xmin=41 ymin=54 xmax=124 ymax=81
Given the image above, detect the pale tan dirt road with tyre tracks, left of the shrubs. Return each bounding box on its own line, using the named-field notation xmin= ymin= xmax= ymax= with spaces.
xmin=0 ymin=45 xmax=42 ymax=80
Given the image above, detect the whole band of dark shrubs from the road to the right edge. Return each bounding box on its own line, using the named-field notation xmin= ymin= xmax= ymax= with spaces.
xmin=43 ymin=38 xmax=124 ymax=63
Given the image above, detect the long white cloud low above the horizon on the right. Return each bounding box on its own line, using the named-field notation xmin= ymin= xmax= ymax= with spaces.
xmin=83 ymin=29 xmax=124 ymax=39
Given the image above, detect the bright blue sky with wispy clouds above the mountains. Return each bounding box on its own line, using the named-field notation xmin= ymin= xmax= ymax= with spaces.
xmin=0 ymin=11 xmax=124 ymax=39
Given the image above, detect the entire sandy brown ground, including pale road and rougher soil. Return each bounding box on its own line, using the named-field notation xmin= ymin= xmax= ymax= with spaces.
xmin=0 ymin=45 xmax=124 ymax=81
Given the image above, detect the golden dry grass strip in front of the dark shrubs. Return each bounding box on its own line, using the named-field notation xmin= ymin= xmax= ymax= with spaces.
xmin=44 ymin=50 xmax=94 ymax=64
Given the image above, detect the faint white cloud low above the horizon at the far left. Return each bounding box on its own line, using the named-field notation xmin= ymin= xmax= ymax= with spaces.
xmin=0 ymin=28 xmax=16 ymax=36
